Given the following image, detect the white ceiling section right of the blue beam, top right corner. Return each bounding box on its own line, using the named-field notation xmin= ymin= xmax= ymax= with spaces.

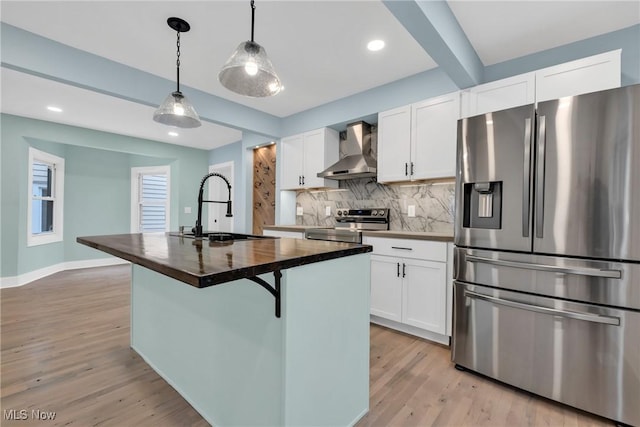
xmin=447 ymin=0 xmax=640 ymax=65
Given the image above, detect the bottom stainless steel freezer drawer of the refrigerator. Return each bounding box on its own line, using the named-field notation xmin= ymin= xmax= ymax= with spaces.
xmin=452 ymin=282 xmax=640 ymax=425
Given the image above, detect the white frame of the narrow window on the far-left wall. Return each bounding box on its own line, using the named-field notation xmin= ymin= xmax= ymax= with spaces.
xmin=27 ymin=147 xmax=65 ymax=247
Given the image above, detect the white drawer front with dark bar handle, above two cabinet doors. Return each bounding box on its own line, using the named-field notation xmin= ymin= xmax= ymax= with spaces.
xmin=362 ymin=236 xmax=447 ymax=262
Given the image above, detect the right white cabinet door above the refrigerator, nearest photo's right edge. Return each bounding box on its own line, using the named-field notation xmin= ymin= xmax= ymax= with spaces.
xmin=536 ymin=49 xmax=622 ymax=102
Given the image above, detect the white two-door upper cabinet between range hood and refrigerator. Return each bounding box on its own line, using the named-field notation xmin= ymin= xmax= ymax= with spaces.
xmin=378 ymin=92 xmax=460 ymax=182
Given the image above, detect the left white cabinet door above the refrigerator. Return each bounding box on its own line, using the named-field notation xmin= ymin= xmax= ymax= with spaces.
xmin=461 ymin=72 xmax=536 ymax=118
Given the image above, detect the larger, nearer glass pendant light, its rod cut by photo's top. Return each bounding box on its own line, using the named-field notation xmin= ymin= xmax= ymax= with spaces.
xmin=218 ymin=0 xmax=282 ymax=97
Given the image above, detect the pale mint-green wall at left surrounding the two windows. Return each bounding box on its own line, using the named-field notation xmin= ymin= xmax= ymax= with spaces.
xmin=0 ymin=114 xmax=207 ymax=277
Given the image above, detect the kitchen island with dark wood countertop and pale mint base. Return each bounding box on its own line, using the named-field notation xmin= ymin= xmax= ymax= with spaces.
xmin=77 ymin=233 xmax=371 ymax=426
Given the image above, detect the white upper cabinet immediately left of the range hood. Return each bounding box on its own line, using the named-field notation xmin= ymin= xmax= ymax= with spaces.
xmin=280 ymin=128 xmax=339 ymax=190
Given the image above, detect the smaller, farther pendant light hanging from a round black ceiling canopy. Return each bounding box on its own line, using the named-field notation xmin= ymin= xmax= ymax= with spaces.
xmin=153 ymin=17 xmax=201 ymax=128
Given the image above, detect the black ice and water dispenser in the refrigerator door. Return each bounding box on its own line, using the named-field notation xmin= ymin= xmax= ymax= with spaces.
xmin=462 ymin=181 xmax=502 ymax=229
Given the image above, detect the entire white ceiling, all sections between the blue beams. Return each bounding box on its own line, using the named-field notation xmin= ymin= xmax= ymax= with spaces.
xmin=0 ymin=0 xmax=640 ymax=149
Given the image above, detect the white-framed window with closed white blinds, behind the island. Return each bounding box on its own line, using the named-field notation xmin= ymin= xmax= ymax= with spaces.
xmin=131 ymin=166 xmax=170 ymax=233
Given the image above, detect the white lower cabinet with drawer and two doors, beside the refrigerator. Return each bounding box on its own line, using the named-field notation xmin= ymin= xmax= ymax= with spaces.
xmin=363 ymin=237 xmax=452 ymax=344
